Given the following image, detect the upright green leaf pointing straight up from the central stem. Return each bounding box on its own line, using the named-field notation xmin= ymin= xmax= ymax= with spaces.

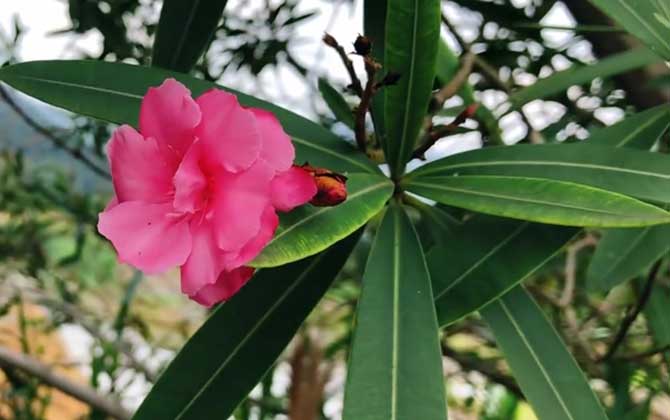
xmin=384 ymin=0 xmax=440 ymax=177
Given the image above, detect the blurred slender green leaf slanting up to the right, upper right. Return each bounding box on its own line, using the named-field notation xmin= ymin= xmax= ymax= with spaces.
xmin=509 ymin=48 xmax=660 ymax=108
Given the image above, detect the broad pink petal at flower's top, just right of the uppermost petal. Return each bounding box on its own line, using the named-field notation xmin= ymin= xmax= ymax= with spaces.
xmin=196 ymin=89 xmax=261 ymax=172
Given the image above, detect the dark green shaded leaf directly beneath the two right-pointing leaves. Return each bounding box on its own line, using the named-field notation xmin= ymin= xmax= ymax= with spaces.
xmin=427 ymin=216 xmax=579 ymax=325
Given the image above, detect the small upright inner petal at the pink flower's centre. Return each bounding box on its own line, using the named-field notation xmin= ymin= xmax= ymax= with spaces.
xmin=174 ymin=141 xmax=207 ymax=213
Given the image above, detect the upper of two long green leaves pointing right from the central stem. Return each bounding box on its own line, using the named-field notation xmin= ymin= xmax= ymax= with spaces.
xmin=408 ymin=144 xmax=670 ymax=203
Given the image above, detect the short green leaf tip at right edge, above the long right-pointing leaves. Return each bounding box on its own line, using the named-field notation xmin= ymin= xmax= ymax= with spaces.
xmin=585 ymin=105 xmax=670 ymax=150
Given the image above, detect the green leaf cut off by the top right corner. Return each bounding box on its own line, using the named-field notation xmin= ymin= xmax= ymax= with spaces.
xmin=591 ymin=0 xmax=670 ymax=60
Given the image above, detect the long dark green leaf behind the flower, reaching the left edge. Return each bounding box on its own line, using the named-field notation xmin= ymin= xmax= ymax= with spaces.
xmin=0 ymin=60 xmax=379 ymax=173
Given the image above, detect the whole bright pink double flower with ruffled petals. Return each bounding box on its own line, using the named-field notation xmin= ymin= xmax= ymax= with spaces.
xmin=98 ymin=79 xmax=316 ymax=306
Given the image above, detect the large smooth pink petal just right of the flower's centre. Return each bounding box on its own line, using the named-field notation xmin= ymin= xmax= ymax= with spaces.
xmin=212 ymin=161 xmax=274 ymax=251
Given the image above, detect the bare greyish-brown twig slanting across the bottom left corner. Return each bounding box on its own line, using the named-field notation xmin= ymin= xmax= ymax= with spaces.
xmin=0 ymin=347 xmax=130 ymax=420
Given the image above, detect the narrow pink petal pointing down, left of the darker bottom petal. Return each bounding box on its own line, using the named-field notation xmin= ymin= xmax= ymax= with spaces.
xmin=181 ymin=220 xmax=225 ymax=296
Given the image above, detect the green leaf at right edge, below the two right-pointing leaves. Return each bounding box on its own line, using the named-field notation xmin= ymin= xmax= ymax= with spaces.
xmin=586 ymin=225 xmax=670 ymax=291
